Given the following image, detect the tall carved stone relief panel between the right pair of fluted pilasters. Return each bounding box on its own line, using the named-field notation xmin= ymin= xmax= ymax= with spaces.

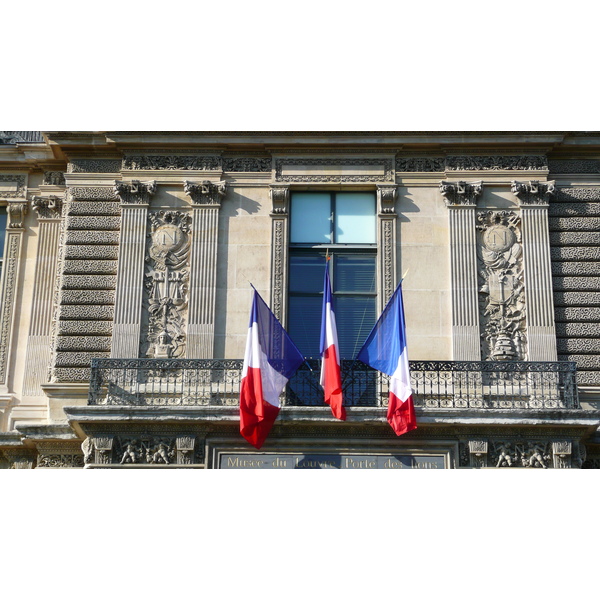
xmin=476 ymin=211 xmax=527 ymax=360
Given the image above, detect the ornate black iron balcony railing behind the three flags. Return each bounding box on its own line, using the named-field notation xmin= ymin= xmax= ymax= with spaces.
xmin=88 ymin=358 xmax=579 ymax=410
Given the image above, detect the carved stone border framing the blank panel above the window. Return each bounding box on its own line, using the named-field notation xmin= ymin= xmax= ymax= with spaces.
xmin=275 ymin=158 xmax=394 ymax=183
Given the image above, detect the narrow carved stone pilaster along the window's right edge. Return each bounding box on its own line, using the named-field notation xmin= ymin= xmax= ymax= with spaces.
xmin=377 ymin=184 xmax=398 ymax=313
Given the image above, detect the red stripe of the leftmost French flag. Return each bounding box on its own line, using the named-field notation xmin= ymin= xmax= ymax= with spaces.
xmin=240 ymin=367 xmax=279 ymax=450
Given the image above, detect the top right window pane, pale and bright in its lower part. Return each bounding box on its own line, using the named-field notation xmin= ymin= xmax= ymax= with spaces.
xmin=335 ymin=193 xmax=377 ymax=244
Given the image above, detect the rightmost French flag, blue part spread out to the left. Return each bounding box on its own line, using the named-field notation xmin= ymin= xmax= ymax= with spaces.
xmin=356 ymin=282 xmax=417 ymax=435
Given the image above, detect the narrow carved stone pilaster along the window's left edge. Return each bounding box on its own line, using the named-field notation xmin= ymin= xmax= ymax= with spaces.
xmin=270 ymin=185 xmax=290 ymax=327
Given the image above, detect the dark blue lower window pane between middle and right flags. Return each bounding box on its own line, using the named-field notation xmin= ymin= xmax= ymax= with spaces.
xmin=335 ymin=296 xmax=376 ymax=359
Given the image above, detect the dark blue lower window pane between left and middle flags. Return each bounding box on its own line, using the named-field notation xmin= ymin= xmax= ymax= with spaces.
xmin=288 ymin=296 xmax=323 ymax=358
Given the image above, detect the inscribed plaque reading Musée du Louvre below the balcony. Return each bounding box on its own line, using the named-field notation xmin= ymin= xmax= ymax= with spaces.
xmin=217 ymin=452 xmax=446 ymax=469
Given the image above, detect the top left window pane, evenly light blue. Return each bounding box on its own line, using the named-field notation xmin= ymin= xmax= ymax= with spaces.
xmin=290 ymin=193 xmax=331 ymax=244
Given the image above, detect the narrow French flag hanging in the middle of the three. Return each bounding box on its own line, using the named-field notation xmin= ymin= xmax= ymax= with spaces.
xmin=321 ymin=258 xmax=346 ymax=421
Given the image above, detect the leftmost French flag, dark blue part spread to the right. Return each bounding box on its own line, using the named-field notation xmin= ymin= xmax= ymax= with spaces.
xmin=240 ymin=290 xmax=304 ymax=449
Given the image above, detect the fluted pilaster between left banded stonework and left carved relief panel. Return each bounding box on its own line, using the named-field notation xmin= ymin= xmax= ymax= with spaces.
xmin=111 ymin=181 xmax=156 ymax=358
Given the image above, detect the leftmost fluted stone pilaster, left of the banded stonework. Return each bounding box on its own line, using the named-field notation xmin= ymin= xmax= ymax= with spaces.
xmin=23 ymin=196 xmax=63 ymax=396
